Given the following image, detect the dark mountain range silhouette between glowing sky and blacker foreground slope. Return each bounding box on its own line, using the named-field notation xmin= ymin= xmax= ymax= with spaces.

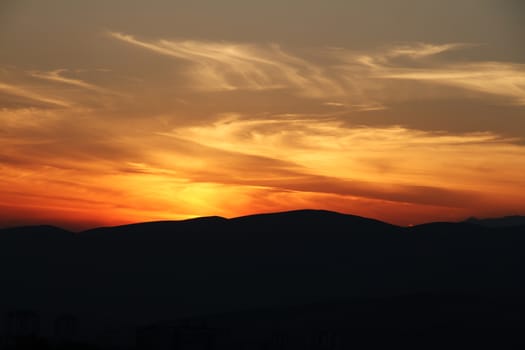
xmin=0 ymin=210 xmax=525 ymax=348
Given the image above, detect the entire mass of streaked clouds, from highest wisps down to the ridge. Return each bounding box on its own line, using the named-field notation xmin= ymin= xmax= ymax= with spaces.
xmin=0 ymin=17 xmax=525 ymax=230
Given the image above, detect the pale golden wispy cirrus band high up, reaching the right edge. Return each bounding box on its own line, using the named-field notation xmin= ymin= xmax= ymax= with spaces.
xmin=108 ymin=32 xmax=525 ymax=106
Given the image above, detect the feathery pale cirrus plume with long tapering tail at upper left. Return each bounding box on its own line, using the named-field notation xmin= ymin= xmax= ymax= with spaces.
xmin=109 ymin=32 xmax=344 ymax=97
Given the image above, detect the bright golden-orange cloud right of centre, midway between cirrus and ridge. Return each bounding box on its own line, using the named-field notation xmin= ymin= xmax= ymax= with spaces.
xmin=164 ymin=116 xmax=525 ymax=205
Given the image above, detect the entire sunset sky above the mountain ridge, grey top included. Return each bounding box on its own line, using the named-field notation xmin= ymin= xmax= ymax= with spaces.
xmin=0 ymin=0 xmax=525 ymax=230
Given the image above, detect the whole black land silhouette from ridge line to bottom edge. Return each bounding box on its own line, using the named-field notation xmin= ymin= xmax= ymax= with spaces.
xmin=0 ymin=210 xmax=525 ymax=349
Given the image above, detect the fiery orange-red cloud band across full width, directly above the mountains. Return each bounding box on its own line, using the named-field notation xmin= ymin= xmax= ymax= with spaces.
xmin=0 ymin=104 xmax=525 ymax=230
